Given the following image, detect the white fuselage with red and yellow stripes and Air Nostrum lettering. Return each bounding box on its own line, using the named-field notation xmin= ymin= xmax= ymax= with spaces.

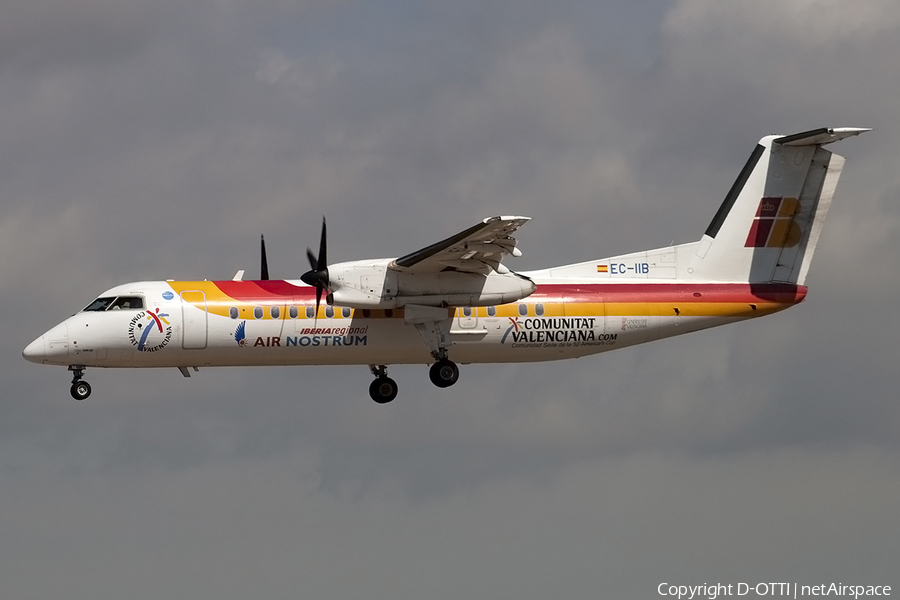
xmin=25 ymin=279 xmax=805 ymax=367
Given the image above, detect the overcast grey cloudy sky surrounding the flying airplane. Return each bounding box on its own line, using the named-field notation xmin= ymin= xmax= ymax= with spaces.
xmin=0 ymin=0 xmax=900 ymax=600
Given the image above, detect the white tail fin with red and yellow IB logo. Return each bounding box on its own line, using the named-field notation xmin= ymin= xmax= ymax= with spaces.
xmin=687 ymin=127 xmax=869 ymax=285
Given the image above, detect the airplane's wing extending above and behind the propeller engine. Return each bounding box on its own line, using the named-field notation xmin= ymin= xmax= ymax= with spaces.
xmin=390 ymin=217 xmax=531 ymax=274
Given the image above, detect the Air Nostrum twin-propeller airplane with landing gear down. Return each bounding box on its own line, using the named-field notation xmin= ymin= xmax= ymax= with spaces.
xmin=22 ymin=127 xmax=870 ymax=404
